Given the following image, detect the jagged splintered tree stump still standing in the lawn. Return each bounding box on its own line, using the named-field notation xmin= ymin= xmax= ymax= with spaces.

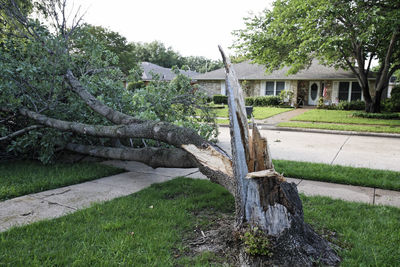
xmin=219 ymin=47 xmax=340 ymax=266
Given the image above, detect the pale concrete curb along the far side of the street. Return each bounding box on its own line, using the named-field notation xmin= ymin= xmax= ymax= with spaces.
xmin=218 ymin=124 xmax=400 ymax=138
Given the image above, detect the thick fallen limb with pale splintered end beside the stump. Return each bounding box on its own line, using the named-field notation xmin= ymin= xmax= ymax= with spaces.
xmin=19 ymin=109 xmax=236 ymax=194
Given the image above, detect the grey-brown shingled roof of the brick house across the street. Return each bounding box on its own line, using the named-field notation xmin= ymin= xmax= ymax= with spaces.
xmin=195 ymin=60 xmax=372 ymax=81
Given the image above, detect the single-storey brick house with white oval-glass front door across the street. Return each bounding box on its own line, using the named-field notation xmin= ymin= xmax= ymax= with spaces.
xmin=195 ymin=60 xmax=375 ymax=105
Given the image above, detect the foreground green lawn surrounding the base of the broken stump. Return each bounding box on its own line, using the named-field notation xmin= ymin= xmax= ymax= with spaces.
xmin=0 ymin=178 xmax=400 ymax=266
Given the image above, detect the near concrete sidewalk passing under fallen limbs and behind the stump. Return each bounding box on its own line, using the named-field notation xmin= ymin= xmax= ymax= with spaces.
xmin=0 ymin=161 xmax=400 ymax=232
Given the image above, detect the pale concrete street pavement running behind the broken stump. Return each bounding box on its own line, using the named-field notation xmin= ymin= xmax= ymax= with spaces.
xmin=218 ymin=127 xmax=400 ymax=171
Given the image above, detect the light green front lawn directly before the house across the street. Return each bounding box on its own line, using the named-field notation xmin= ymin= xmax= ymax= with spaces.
xmin=291 ymin=109 xmax=400 ymax=126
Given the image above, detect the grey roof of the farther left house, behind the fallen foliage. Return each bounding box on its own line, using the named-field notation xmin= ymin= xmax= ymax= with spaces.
xmin=140 ymin=62 xmax=199 ymax=81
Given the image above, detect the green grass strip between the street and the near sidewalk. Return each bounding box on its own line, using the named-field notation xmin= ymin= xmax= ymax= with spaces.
xmin=273 ymin=160 xmax=400 ymax=191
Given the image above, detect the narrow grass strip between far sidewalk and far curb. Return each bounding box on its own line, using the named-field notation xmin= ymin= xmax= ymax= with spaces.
xmin=278 ymin=122 xmax=400 ymax=133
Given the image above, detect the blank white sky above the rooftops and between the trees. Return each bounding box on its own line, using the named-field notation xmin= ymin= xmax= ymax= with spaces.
xmin=71 ymin=0 xmax=272 ymax=59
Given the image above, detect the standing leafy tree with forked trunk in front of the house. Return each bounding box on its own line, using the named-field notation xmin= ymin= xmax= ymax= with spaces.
xmin=234 ymin=0 xmax=400 ymax=112
